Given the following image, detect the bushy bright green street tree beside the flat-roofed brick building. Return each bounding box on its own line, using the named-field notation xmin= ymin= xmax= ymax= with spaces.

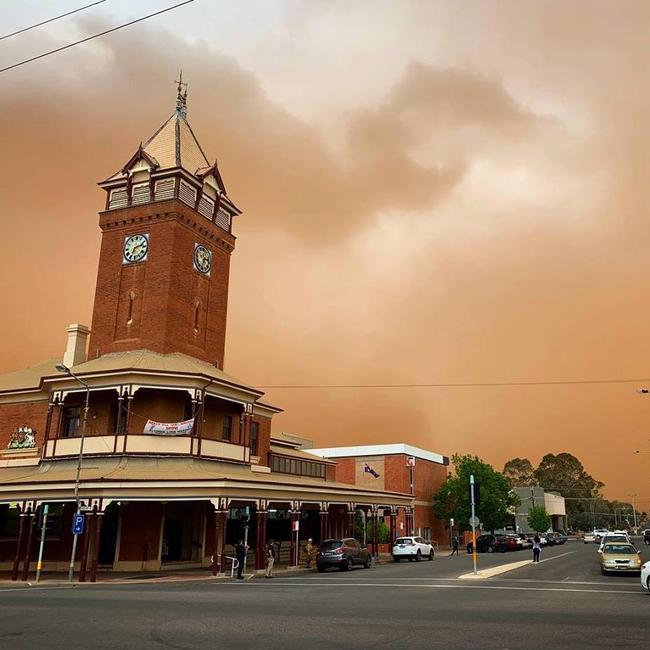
xmin=433 ymin=454 xmax=519 ymax=530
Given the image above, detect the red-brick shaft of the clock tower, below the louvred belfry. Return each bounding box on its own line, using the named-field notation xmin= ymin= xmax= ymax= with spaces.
xmin=89 ymin=199 xmax=235 ymax=367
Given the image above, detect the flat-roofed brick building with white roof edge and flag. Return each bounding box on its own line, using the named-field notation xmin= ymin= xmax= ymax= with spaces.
xmin=310 ymin=444 xmax=449 ymax=546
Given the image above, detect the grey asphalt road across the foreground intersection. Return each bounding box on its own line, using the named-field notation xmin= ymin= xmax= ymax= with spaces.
xmin=0 ymin=542 xmax=650 ymax=650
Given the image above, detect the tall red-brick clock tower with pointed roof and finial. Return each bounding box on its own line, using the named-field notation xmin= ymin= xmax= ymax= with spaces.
xmin=88 ymin=82 xmax=241 ymax=368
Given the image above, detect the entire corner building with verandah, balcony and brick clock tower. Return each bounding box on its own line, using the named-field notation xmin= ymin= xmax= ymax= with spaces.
xmin=0 ymin=87 xmax=413 ymax=580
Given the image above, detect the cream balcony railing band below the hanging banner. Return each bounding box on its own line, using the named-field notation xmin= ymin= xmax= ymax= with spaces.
xmin=43 ymin=433 xmax=250 ymax=463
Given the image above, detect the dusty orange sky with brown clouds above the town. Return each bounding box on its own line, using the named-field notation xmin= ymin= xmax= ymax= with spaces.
xmin=0 ymin=2 xmax=650 ymax=502
